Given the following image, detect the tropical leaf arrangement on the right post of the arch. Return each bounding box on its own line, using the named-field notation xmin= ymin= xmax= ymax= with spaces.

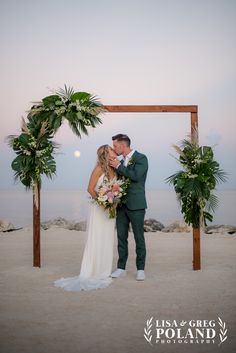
xmin=166 ymin=133 xmax=226 ymax=228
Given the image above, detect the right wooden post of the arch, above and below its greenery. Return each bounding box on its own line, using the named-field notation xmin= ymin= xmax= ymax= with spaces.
xmin=191 ymin=112 xmax=201 ymax=271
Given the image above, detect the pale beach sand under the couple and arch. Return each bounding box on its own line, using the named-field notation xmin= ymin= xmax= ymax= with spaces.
xmin=0 ymin=228 xmax=236 ymax=353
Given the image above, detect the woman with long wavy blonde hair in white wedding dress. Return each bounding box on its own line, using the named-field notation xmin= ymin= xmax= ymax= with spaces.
xmin=54 ymin=145 xmax=117 ymax=291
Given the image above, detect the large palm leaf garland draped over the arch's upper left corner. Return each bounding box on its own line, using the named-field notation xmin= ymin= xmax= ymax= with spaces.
xmin=8 ymin=85 xmax=104 ymax=188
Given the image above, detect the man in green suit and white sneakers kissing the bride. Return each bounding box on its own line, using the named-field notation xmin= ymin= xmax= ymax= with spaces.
xmin=110 ymin=134 xmax=148 ymax=281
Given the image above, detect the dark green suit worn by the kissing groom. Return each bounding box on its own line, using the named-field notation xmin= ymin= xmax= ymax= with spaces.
xmin=116 ymin=151 xmax=148 ymax=270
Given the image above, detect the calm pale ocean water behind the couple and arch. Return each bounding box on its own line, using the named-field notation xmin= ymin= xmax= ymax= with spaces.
xmin=0 ymin=190 xmax=236 ymax=227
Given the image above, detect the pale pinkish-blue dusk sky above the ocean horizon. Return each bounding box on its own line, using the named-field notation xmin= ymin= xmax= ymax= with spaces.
xmin=0 ymin=0 xmax=236 ymax=191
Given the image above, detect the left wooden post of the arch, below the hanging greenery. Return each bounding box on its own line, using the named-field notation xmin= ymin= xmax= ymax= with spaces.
xmin=33 ymin=182 xmax=40 ymax=267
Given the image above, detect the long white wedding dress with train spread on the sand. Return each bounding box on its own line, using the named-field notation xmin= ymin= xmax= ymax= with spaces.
xmin=54 ymin=174 xmax=115 ymax=291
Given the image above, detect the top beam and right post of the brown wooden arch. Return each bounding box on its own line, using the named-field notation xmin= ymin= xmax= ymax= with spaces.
xmin=104 ymin=105 xmax=201 ymax=270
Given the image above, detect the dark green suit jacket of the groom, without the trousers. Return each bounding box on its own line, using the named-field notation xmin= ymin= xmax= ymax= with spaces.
xmin=117 ymin=151 xmax=148 ymax=210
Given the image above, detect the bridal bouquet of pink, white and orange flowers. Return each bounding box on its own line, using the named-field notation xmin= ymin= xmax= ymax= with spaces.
xmin=95 ymin=178 xmax=130 ymax=218
